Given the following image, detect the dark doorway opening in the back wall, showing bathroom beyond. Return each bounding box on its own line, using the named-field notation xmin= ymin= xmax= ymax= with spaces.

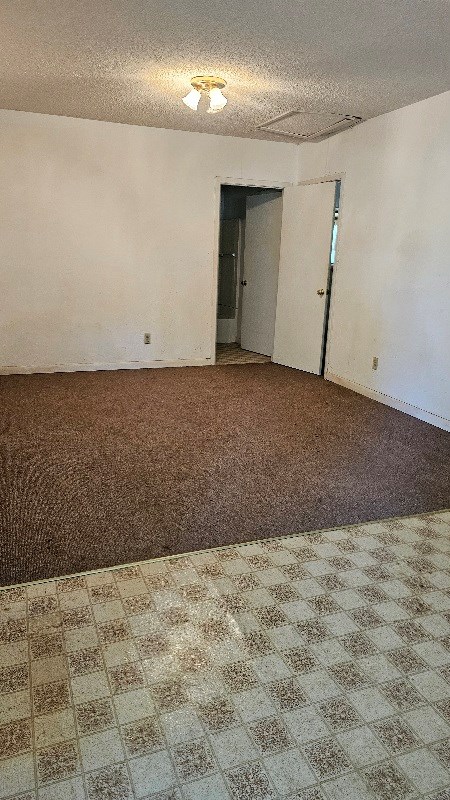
xmin=216 ymin=185 xmax=282 ymax=364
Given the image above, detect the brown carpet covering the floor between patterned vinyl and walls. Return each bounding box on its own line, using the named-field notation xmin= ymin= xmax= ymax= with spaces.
xmin=0 ymin=364 xmax=450 ymax=585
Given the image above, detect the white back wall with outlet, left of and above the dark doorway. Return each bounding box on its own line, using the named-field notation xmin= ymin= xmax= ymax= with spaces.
xmin=0 ymin=111 xmax=298 ymax=372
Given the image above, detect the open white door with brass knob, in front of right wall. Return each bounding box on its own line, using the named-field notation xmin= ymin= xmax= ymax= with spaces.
xmin=272 ymin=181 xmax=336 ymax=375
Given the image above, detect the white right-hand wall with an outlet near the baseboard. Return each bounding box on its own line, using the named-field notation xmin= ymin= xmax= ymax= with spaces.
xmin=299 ymin=92 xmax=450 ymax=427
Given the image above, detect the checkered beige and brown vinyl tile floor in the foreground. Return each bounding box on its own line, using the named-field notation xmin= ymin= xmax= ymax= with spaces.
xmin=0 ymin=512 xmax=450 ymax=800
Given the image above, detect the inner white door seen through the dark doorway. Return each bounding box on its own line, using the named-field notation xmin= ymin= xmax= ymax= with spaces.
xmin=241 ymin=192 xmax=283 ymax=356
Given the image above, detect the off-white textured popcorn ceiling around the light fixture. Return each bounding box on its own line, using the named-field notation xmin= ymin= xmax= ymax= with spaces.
xmin=0 ymin=0 xmax=450 ymax=139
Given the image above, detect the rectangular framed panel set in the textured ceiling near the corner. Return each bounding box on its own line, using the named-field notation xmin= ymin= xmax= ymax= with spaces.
xmin=258 ymin=111 xmax=363 ymax=142
